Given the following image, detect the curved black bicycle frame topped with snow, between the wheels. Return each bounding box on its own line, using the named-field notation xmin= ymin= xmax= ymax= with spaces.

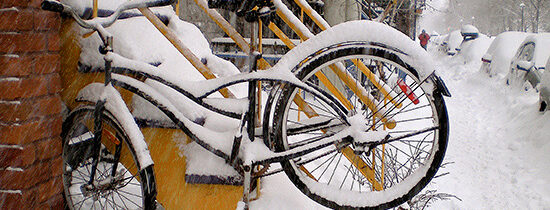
xmin=94 ymin=52 xmax=354 ymax=169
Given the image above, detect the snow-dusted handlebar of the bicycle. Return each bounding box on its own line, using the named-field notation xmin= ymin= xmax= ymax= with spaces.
xmin=41 ymin=0 xmax=175 ymax=31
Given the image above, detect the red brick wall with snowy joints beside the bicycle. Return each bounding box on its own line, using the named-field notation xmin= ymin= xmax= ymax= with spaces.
xmin=0 ymin=0 xmax=64 ymax=209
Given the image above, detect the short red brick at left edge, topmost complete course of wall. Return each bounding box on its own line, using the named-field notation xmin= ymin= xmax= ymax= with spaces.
xmin=0 ymin=9 xmax=33 ymax=31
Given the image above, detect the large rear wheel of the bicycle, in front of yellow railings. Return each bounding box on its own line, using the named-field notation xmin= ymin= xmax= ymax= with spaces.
xmin=272 ymin=42 xmax=448 ymax=209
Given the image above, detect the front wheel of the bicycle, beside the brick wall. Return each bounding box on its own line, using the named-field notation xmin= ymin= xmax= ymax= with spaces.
xmin=61 ymin=106 xmax=156 ymax=209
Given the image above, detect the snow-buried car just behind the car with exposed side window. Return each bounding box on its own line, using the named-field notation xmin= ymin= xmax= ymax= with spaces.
xmin=481 ymin=31 xmax=531 ymax=78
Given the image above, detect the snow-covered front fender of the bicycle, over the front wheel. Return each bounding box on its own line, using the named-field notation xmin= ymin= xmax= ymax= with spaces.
xmin=76 ymin=83 xmax=153 ymax=170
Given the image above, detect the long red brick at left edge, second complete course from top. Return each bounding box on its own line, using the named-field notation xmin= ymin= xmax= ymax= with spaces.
xmin=0 ymin=32 xmax=47 ymax=53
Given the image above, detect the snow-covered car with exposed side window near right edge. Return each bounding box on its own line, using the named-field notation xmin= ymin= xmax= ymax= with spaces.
xmin=506 ymin=33 xmax=550 ymax=89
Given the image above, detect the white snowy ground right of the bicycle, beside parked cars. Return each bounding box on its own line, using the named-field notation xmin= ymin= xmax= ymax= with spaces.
xmin=422 ymin=45 xmax=550 ymax=209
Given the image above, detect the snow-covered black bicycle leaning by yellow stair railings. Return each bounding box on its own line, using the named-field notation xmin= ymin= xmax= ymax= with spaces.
xmin=42 ymin=0 xmax=450 ymax=209
